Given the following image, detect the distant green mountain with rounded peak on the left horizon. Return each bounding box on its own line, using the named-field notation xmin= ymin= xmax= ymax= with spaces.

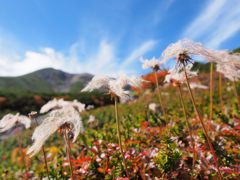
xmin=0 ymin=68 xmax=93 ymax=93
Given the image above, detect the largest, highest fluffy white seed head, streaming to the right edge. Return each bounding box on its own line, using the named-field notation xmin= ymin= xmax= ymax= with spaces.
xmin=161 ymin=39 xmax=240 ymax=81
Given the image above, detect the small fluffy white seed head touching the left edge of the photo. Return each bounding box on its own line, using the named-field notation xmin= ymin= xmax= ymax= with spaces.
xmin=0 ymin=113 xmax=31 ymax=133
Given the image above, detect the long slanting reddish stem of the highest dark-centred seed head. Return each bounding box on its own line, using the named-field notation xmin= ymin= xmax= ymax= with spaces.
xmin=183 ymin=66 xmax=223 ymax=180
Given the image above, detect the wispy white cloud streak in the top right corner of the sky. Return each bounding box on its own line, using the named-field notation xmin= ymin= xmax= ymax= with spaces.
xmin=182 ymin=0 xmax=240 ymax=48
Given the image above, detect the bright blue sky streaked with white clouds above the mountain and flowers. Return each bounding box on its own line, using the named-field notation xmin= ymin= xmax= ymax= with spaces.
xmin=0 ymin=0 xmax=240 ymax=76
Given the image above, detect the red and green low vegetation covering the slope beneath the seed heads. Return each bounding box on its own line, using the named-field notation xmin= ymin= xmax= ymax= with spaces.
xmin=0 ymin=69 xmax=240 ymax=179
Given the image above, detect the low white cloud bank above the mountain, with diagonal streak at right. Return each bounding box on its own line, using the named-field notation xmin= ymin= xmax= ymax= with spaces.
xmin=0 ymin=40 xmax=156 ymax=76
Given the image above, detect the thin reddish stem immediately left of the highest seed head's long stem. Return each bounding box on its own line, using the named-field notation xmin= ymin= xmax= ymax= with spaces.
xmin=178 ymin=85 xmax=197 ymax=169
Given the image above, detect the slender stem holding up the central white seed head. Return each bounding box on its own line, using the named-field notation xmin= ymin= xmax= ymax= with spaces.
xmin=114 ymin=97 xmax=130 ymax=179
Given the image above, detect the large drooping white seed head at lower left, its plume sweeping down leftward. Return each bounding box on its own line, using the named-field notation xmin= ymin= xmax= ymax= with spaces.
xmin=27 ymin=106 xmax=84 ymax=157
